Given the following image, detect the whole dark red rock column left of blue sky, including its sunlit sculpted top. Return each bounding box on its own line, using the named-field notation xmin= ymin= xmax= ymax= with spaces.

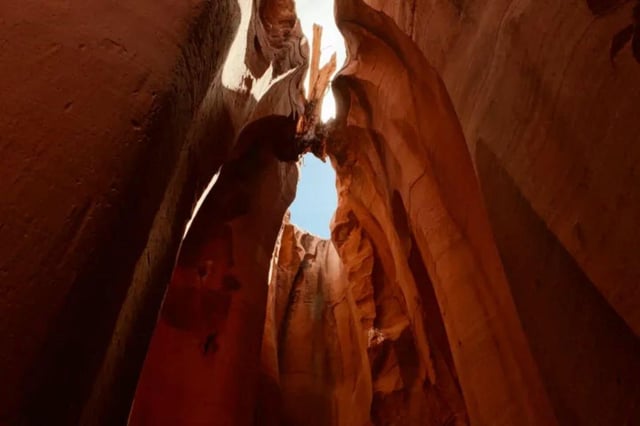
xmin=129 ymin=1 xmax=306 ymax=426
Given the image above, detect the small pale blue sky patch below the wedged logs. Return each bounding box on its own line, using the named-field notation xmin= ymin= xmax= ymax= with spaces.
xmin=289 ymin=154 xmax=338 ymax=238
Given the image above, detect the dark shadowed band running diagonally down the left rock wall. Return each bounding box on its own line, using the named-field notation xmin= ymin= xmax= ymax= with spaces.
xmin=16 ymin=1 xmax=240 ymax=425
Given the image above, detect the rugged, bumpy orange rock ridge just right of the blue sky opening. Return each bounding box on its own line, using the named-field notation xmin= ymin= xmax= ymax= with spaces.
xmin=332 ymin=203 xmax=468 ymax=425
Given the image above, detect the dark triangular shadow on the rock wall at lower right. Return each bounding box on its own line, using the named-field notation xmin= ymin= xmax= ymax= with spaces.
xmin=476 ymin=141 xmax=640 ymax=426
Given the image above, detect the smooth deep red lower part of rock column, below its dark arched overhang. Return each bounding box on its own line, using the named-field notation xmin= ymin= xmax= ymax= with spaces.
xmin=129 ymin=145 xmax=297 ymax=425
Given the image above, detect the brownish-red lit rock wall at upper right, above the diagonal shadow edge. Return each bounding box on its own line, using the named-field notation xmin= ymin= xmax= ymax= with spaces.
xmin=368 ymin=0 xmax=640 ymax=335
